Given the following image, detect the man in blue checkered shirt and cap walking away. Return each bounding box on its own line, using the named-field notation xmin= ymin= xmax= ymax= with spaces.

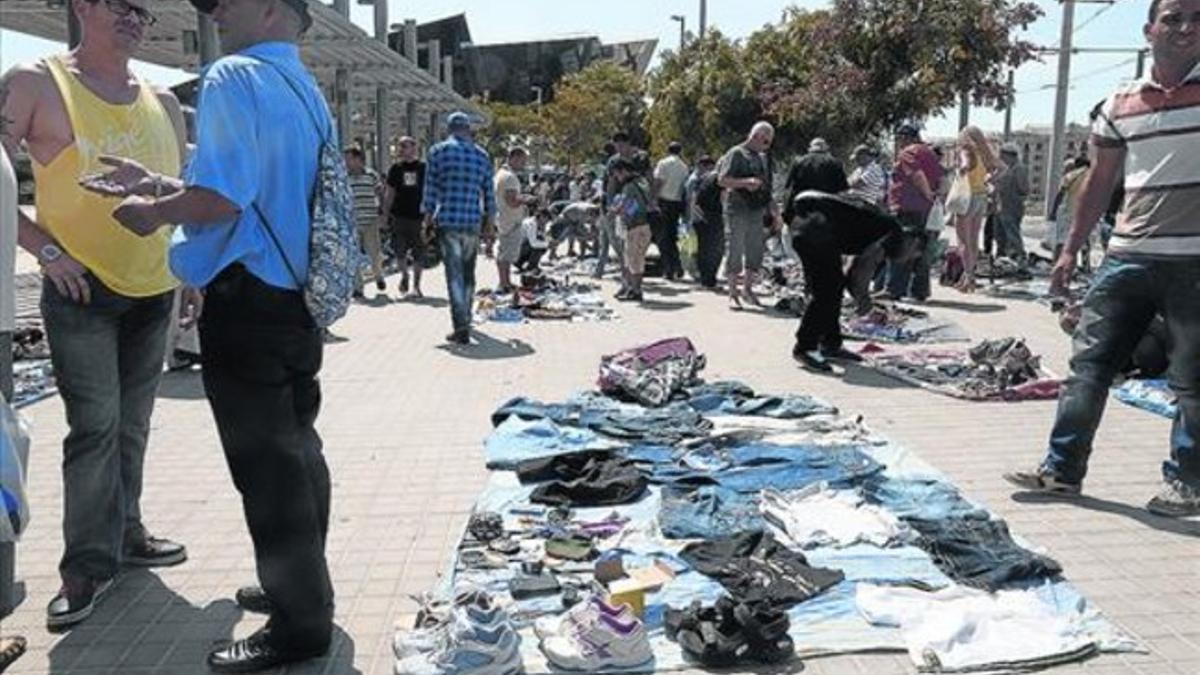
xmin=421 ymin=113 xmax=496 ymax=345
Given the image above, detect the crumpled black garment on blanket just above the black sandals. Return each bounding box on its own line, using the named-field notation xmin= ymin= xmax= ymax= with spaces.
xmin=679 ymin=530 xmax=845 ymax=609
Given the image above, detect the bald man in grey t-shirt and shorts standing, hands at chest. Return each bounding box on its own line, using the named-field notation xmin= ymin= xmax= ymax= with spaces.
xmin=718 ymin=121 xmax=780 ymax=310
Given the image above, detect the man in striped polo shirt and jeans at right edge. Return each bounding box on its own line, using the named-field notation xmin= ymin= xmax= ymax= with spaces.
xmin=1006 ymin=0 xmax=1200 ymax=516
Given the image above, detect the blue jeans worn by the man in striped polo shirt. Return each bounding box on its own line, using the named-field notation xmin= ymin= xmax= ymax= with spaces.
xmin=1043 ymin=256 xmax=1200 ymax=486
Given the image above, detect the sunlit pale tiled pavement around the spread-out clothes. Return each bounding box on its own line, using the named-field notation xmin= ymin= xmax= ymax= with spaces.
xmin=2 ymin=253 xmax=1200 ymax=675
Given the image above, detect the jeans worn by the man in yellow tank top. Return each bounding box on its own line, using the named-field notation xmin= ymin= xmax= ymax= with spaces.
xmin=41 ymin=274 xmax=172 ymax=579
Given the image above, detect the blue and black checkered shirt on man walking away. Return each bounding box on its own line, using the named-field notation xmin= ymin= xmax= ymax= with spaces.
xmin=421 ymin=136 xmax=496 ymax=232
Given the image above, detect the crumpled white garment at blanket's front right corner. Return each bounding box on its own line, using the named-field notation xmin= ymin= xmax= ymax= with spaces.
xmin=856 ymin=584 xmax=1097 ymax=673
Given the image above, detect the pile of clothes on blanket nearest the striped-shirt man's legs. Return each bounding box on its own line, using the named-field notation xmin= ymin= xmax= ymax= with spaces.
xmin=864 ymin=338 xmax=1060 ymax=401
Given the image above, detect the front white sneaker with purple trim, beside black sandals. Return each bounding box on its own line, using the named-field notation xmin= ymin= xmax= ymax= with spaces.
xmin=541 ymin=614 xmax=654 ymax=673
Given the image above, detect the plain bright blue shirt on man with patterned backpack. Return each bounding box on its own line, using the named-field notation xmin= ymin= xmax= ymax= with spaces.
xmin=170 ymin=42 xmax=328 ymax=288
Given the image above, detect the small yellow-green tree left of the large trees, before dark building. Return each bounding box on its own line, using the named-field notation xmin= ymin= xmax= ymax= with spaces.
xmin=540 ymin=61 xmax=646 ymax=167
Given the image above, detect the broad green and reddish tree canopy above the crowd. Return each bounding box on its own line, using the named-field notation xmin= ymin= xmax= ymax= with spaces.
xmin=649 ymin=0 xmax=1042 ymax=155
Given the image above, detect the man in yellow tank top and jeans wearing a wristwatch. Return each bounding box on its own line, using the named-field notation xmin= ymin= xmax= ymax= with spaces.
xmin=0 ymin=0 xmax=187 ymax=628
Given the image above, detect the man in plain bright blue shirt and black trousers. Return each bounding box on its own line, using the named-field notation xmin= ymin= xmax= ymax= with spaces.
xmin=92 ymin=0 xmax=336 ymax=673
